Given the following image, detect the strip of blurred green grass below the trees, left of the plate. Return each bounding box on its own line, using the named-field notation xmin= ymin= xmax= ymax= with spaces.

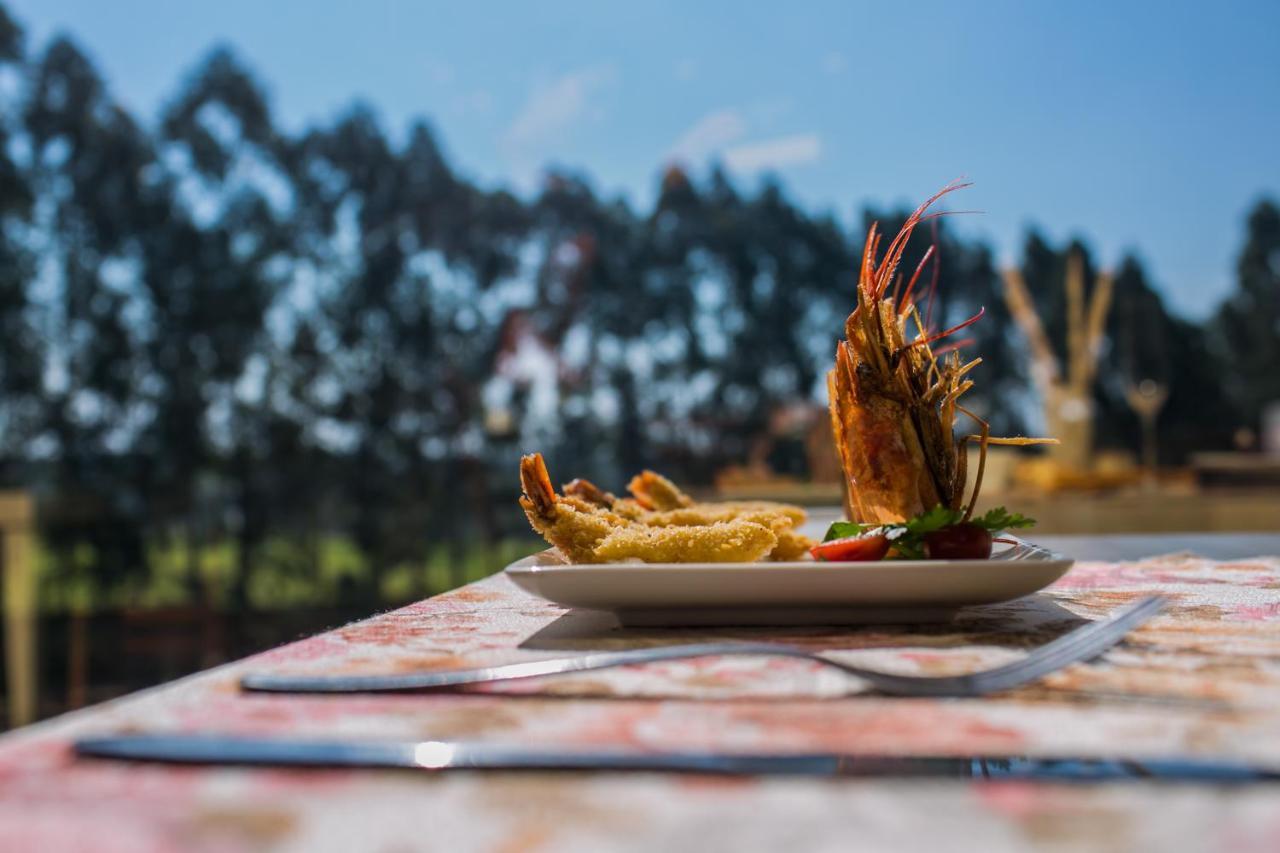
xmin=36 ymin=535 xmax=540 ymax=612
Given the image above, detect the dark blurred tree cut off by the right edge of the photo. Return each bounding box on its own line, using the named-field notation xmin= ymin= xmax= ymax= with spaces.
xmin=1213 ymin=199 xmax=1280 ymax=430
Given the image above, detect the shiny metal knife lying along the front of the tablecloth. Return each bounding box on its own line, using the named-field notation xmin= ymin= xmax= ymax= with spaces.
xmin=76 ymin=734 xmax=1280 ymax=784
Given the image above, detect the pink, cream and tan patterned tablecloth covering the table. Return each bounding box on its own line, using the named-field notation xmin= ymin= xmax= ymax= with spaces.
xmin=0 ymin=555 xmax=1280 ymax=852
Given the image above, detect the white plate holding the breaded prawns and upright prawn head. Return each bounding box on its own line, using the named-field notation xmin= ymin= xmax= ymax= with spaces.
xmin=507 ymin=540 xmax=1074 ymax=625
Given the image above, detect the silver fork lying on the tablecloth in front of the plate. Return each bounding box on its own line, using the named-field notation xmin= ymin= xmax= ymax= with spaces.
xmin=241 ymin=596 xmax=1166 ymax=697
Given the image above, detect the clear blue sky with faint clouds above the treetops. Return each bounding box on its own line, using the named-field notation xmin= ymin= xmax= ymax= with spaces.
xmin=9 ymin=0 xmax=1280 ymax=315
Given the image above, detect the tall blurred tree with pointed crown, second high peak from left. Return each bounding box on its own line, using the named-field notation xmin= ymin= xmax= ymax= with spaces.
xmin=154 ymin=49 xmax=293 ymax=605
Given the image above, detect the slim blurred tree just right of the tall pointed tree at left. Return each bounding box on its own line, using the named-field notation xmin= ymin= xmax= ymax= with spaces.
xmin=291 ymin=106 xmax=419 ymax=596
